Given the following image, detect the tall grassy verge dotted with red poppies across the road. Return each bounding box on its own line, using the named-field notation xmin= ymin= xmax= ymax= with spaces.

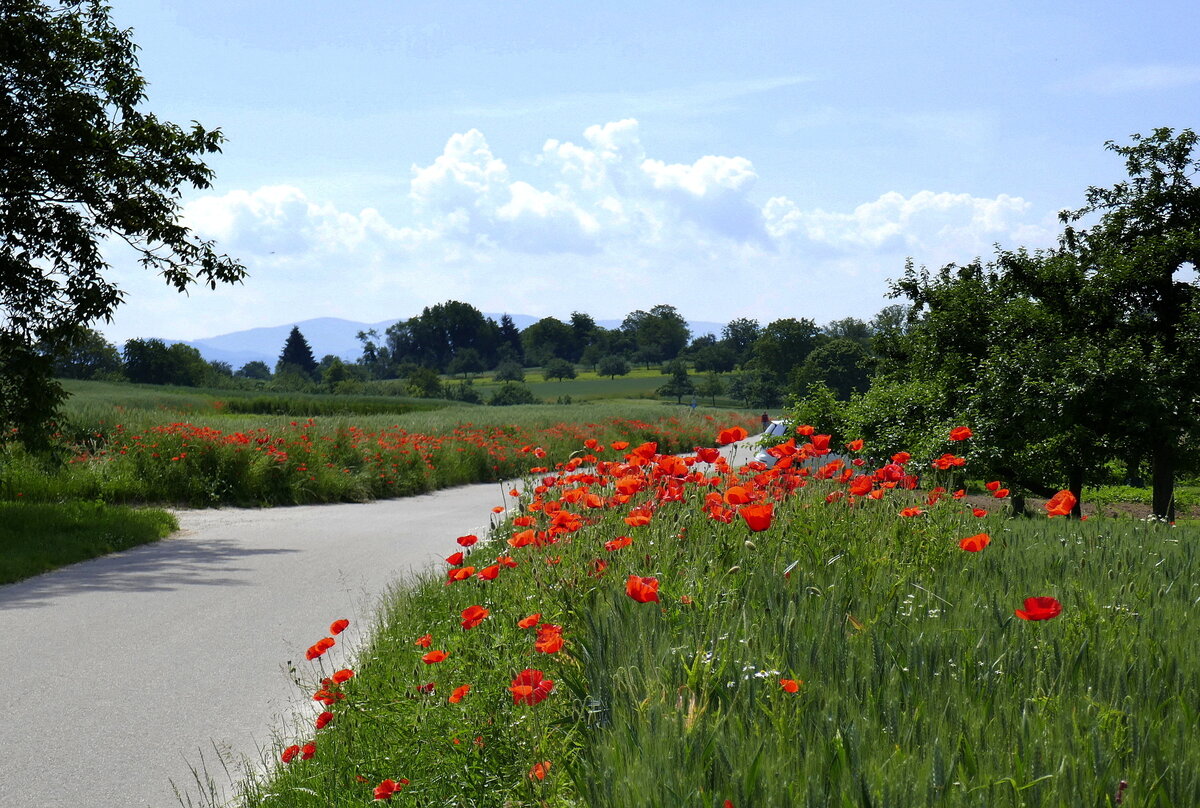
xmin=0 ymin=401 xmax=754 ymax=507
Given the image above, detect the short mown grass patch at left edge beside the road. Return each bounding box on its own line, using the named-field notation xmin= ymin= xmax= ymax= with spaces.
xmin=0 ymin=502 xmax=179 ymax=583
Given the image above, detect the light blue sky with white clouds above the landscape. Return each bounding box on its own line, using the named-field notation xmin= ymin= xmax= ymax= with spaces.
xmin=103 ymin=0 xmax=1200 ymax=341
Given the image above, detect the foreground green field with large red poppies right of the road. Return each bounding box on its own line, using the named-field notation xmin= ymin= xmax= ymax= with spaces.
xmin=231 ymin=427 xmax=1200 ymax=808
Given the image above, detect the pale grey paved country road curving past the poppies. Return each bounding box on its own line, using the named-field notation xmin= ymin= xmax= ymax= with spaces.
xmin=0 ymin=438 xmax=754 ymax=808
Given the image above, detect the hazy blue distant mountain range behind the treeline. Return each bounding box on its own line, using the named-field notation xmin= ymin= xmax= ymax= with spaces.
xmin=156 ymin=312 xmax=725 ymax=370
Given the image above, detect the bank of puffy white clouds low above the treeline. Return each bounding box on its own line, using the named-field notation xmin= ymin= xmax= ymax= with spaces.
xmin=124 ymin=119 xmax=1054 ymax=339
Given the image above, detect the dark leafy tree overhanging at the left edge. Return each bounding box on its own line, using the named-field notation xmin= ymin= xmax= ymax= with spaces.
xmin=0 ymin=0 xmax=246 ymax=444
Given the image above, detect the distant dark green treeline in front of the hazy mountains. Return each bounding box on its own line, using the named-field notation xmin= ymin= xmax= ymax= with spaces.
xmin=49 ymin=300 xmax=905 ymax=407
